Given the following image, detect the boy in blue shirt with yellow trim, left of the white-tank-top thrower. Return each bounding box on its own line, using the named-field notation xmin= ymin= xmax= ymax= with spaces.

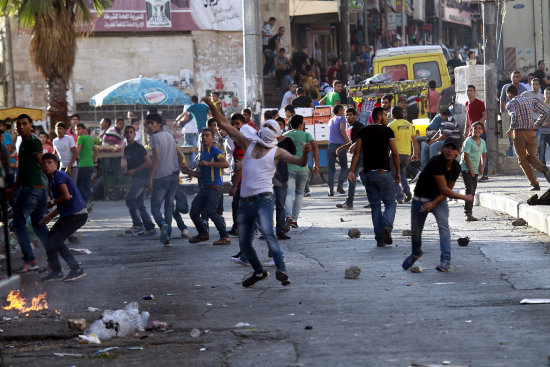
xmin=184 ymin=128 xmax=231 ymax=245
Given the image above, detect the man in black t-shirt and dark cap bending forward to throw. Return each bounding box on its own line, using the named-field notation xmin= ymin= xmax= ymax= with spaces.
xmin=402 ymin=138 xmax=474 ymax=272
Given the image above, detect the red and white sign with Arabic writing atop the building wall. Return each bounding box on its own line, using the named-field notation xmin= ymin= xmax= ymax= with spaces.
xmin=90 ymin=0 xmax=243 ymax=32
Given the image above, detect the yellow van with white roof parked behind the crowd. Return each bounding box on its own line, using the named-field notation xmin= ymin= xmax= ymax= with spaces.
xmin=373 ymin=45 xmax=451 ymax=92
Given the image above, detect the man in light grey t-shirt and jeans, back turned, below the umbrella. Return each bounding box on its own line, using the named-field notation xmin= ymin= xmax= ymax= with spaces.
xmin=145 ymin=113 xmax=181 ymax=247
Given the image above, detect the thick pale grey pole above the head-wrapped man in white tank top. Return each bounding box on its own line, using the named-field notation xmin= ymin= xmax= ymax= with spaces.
xmin=243 ymin=0 xmax=263 ymax=116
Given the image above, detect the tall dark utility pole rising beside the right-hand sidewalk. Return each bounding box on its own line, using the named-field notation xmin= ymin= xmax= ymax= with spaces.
xmin=482 ymin=0 xmax=500 ymax=174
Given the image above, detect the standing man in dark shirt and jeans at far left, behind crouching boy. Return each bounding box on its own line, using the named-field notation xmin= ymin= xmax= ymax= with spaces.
xmin=6 ymin=114 xmax=48 ymax=274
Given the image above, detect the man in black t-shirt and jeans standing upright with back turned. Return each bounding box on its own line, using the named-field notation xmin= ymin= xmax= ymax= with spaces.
xmin=348 ymin=107 xmax=401 ymax=247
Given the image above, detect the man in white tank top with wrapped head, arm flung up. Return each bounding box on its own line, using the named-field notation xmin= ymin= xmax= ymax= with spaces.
xmin=203 ymin=97 xmax=311 ymax=287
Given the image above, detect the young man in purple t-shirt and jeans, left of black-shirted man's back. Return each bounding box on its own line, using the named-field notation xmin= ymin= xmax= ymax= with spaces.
xmin=327 ymin=104 xmax=349 ymax=196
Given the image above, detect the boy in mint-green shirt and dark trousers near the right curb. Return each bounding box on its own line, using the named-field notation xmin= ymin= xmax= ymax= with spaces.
xmin=460 ymin=121 xmax=487 ymax=222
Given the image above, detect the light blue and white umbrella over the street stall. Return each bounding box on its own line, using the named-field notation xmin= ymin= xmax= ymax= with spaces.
xmin=90 ymin=77 xmax=191 ymax=107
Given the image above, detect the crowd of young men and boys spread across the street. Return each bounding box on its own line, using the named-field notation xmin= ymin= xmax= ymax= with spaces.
xmin=4 ymin=56 xmax=550 ymax=287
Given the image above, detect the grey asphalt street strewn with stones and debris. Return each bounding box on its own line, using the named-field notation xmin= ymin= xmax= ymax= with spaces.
xmin=0 ymin=180 xmax=550 ymax=367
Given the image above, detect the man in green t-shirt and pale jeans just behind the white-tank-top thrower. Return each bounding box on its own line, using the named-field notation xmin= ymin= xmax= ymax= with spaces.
xmin=284 ymin=115 xmax=319 ymax=232
